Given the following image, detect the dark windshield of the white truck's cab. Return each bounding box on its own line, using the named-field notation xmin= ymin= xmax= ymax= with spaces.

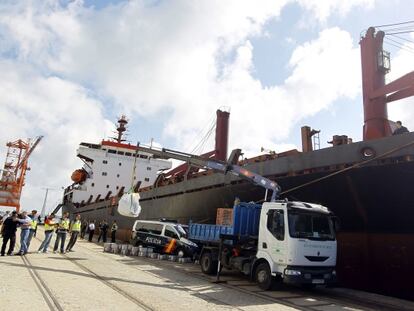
xmin=288 ymin=211 xmax=335 ymax=240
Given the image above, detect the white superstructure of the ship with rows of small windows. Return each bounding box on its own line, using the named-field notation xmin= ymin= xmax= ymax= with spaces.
xmin=64 ymin=116 xmax=172 ymax=205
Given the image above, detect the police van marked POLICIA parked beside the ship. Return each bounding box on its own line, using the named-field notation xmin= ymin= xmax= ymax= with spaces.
xmin=131 ymin=220 xmax=198 ymax=257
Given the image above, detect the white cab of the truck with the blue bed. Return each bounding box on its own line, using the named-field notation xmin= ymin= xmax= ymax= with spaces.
xmin=253 ymin=201 xmax=337 ymax=289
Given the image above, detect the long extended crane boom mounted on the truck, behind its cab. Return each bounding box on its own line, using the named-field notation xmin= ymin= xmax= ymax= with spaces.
xmin=137 ymin=144 xmax=280 ymax=202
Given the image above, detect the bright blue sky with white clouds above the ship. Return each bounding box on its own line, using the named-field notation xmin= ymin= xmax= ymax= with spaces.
xmin=0 ymin=0 xmax=414 ymax=214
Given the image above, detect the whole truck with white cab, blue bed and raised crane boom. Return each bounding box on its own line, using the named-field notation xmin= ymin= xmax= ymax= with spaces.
xmin=124 ymin=144 xmax=337 ymax=290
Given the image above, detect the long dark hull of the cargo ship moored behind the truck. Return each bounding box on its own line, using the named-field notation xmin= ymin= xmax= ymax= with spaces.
xmin=63 ymin=134 xmax=414 ymax=300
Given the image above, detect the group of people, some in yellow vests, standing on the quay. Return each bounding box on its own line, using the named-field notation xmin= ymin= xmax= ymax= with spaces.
xmin=0 ymin=210 xmax=118 ymax=256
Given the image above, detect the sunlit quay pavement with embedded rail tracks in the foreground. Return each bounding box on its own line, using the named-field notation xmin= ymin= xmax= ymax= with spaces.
xmin=0 ymin=228 xmax=414 ymax=311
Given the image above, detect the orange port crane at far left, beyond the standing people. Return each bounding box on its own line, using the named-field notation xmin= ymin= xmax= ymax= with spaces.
xmin=0 ymin=136 xmax=43 ymax=212
